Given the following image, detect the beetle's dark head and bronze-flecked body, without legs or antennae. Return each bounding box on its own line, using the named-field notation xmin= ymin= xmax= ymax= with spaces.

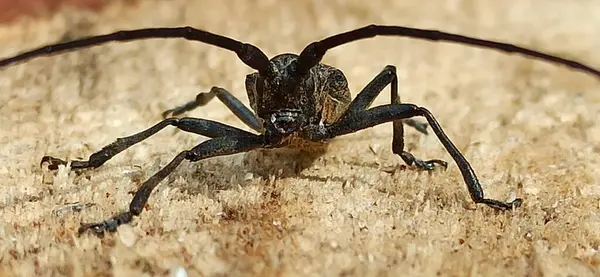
xmin=246 ymin=54 xmax=351 ymax=135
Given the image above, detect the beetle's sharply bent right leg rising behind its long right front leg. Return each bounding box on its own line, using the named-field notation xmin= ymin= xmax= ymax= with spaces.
xmin=342 ymin=65 xmax=448 ymax=170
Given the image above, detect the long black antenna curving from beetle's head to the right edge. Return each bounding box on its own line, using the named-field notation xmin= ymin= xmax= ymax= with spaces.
xmin=298 ymin=25 xmax=600 ymax=77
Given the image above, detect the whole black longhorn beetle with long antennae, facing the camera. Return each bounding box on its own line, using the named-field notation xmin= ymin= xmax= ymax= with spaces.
xmin=0 ymin=25 xmax=600 ymax=235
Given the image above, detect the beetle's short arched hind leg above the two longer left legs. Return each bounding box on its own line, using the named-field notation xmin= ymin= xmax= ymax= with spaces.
xmin=162 ymin=87 xmax=263 ymax=133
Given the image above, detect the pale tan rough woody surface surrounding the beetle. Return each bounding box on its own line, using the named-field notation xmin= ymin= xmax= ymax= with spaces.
xmin=0 ymin=0 xmax=600 ymax=276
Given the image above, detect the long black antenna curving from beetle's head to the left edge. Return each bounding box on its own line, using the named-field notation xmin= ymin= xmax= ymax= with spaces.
xmin=0 ymin=27 xmax=270 ymax=74
